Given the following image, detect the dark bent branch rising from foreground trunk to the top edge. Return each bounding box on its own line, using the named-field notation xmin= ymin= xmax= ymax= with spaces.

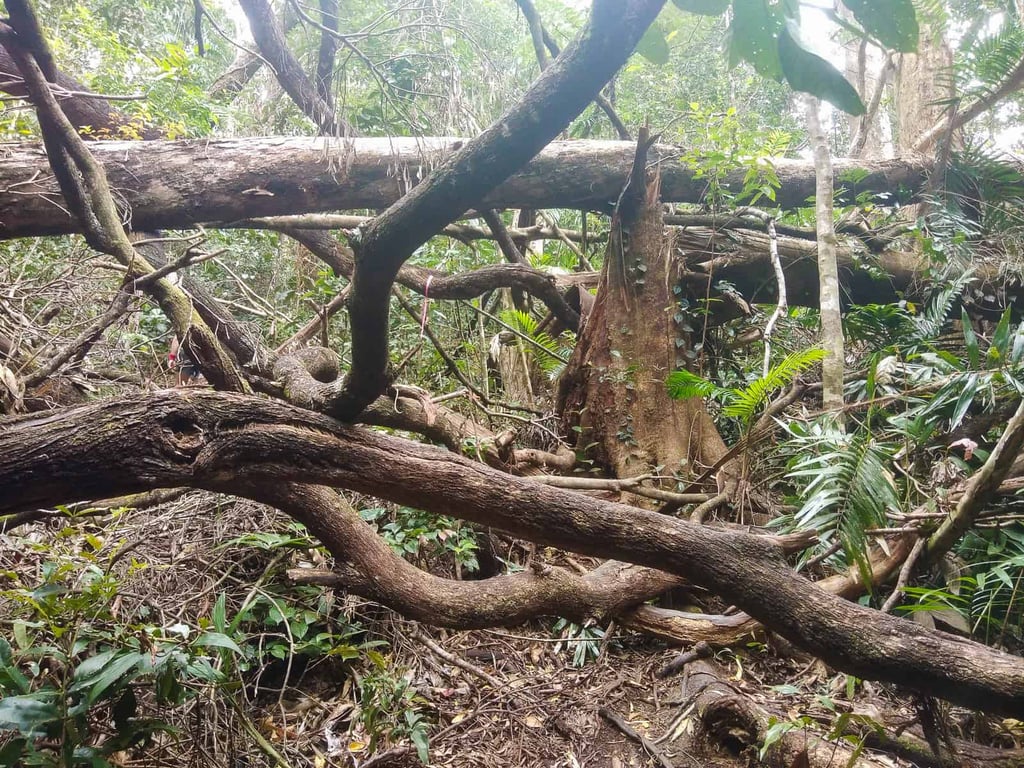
xmin=327 ymin=0 xmax=665 ymax=420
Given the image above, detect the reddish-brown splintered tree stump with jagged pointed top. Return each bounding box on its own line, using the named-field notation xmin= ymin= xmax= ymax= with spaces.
xmin=558 ymin=139 xmax=726 ymax=477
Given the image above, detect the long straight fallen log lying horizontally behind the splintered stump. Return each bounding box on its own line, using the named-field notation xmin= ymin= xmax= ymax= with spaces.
xmin=0 ymin=137 xmax=928 ymax=239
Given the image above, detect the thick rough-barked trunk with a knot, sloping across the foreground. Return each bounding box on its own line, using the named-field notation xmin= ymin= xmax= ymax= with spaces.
xmin=0 ymin=390 xmax=1024 ymax=715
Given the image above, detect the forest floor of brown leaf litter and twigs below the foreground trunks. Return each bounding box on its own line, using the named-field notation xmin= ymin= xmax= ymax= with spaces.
xmin=0 ymin=493 xmax=999 ymax=768
